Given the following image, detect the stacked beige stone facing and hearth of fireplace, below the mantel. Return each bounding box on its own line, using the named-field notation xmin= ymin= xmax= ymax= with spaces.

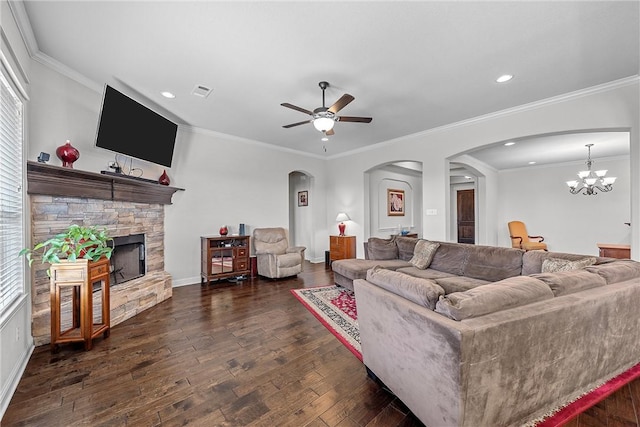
xmin=30 ymin=194 xmax=172 ymax=346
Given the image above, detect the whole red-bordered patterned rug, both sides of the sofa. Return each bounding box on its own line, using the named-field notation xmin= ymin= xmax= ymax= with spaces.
xmin=291 ymin=286 xmax=640 ymax=427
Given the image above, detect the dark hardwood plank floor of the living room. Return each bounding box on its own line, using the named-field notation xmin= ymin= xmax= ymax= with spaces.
xmin=1 ymin=263 xmax=640 ymax=427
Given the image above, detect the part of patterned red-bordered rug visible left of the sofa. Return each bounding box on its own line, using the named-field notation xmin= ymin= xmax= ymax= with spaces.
xmin=291 ymin=286 xmax=362 ymax=361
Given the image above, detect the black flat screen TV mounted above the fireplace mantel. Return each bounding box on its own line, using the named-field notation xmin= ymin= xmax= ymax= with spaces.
xmin=96 ymin=85 xmax=178 ymax=167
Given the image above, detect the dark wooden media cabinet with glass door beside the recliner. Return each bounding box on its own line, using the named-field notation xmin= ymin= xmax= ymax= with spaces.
xmin=200 ymin=236 xmax=251 ymax=284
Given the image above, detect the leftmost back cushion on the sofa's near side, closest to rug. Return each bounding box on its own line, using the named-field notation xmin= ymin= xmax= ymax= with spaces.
xmin=364 ymin=267 xmax=444 ymax=310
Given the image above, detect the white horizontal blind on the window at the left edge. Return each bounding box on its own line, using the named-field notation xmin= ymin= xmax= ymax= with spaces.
xmin=0 ymin=70 xmax=25 ymax=314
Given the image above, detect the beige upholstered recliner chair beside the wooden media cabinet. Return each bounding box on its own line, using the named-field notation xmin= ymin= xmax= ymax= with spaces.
xmin=252 ymin=227 xmax=306 ymax=279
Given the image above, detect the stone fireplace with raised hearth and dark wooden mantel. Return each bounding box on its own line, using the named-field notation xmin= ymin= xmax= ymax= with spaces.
xmin=27 ymin=162 xmax=179 ymax=346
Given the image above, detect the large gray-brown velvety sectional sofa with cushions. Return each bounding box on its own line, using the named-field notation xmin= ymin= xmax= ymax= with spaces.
xmin=332 ymin=238 xmax=640 ymax=427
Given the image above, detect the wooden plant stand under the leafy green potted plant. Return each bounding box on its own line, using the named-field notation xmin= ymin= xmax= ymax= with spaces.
xmin=50 ymin=257 xmax=111 ymax=353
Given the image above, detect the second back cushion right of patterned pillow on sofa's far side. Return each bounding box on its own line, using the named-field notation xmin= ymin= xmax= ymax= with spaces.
xmin=463 ymin=245 xmax=524 ymax=282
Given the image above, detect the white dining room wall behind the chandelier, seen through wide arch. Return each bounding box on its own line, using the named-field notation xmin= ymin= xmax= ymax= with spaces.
xmin=497 ymin=158 xmax=631 ymax=255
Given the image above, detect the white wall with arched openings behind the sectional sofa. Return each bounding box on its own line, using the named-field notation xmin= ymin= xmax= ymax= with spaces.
xmin=327 ymin=78 xmax=640 ymax=259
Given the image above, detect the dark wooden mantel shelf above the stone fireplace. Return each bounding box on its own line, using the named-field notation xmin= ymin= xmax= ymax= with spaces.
xmin=27 ymin=161 xmax=184 ymax=205
